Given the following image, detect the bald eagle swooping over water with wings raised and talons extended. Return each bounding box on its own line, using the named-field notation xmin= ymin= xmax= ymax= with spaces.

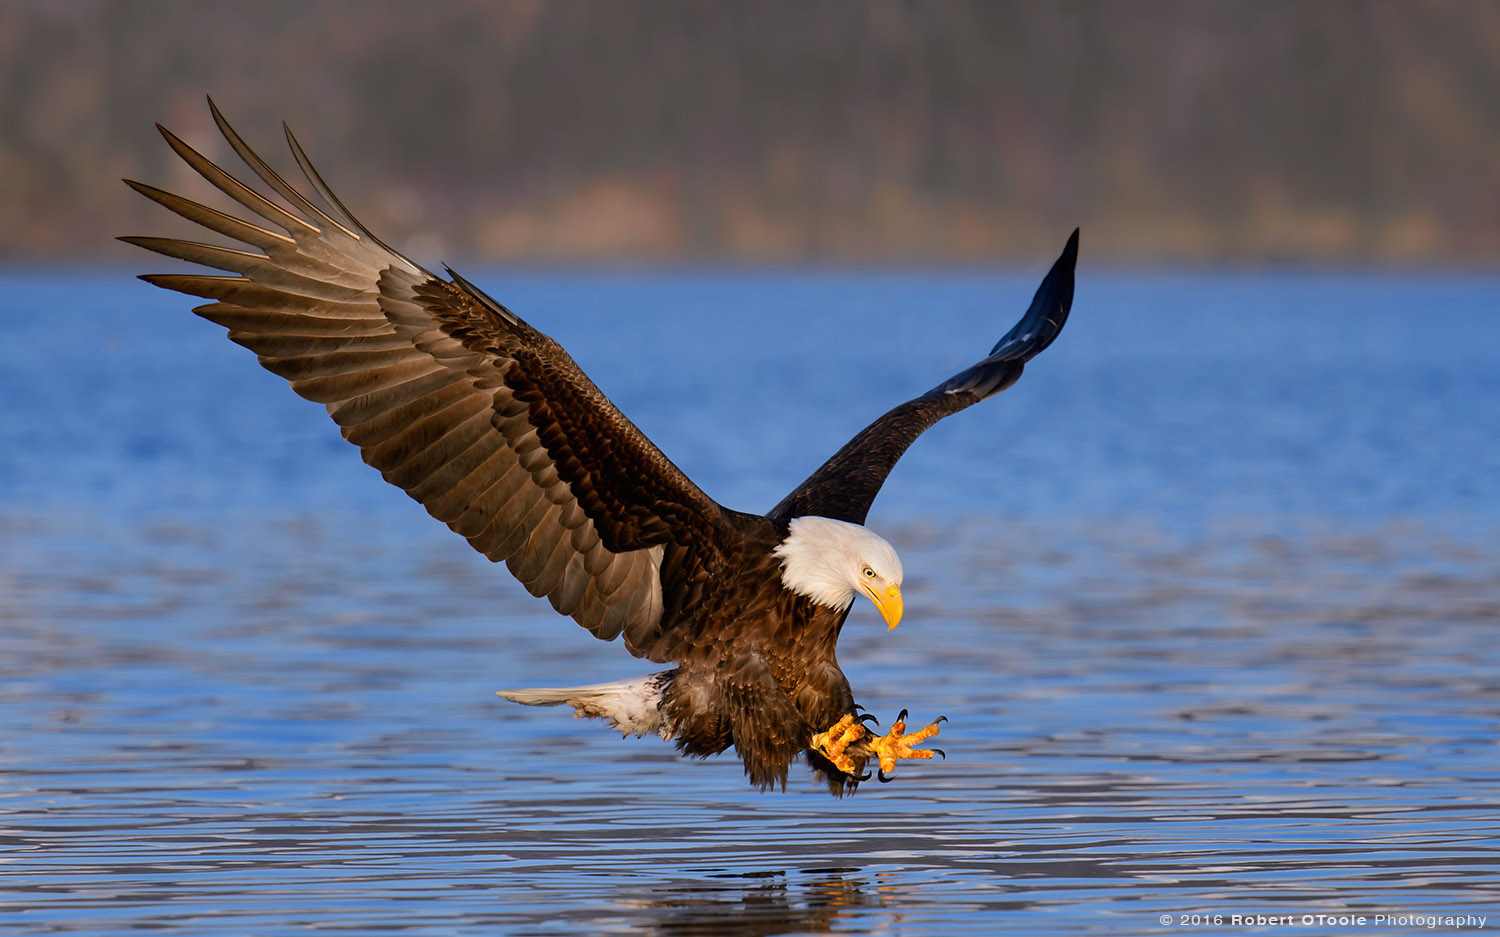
xmin=122 ymin=100 xmax=1079 ymax=795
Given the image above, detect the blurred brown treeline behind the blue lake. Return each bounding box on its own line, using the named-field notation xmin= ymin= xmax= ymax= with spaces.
xmin=0 ymin=0 xmax=1500 ymax=265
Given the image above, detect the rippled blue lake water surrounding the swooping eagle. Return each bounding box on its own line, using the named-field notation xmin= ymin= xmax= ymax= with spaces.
xmin=0 ymin=269 xmax=1500 ymax=936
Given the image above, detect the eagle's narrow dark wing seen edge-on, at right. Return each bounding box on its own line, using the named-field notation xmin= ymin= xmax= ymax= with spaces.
xmin=767 ymin=229 xmax=1079 ymax=523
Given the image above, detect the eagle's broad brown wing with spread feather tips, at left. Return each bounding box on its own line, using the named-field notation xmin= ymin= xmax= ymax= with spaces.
xmin=122 ymin=100 xmax=725 ymax=654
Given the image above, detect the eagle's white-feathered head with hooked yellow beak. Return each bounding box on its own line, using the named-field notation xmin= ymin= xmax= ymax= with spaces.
xmin=776 ymin=517 xmax=902 ymax=628
